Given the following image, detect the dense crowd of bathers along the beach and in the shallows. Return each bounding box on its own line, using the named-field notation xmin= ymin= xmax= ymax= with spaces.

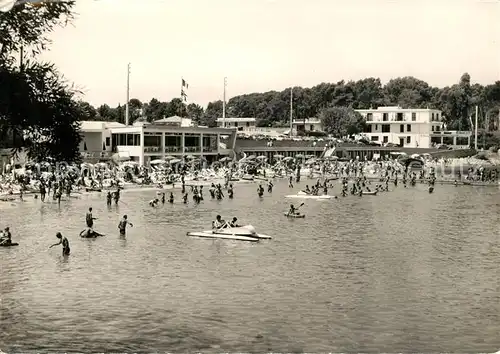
xmin=0 ymin=154 xmax=499 ymax=249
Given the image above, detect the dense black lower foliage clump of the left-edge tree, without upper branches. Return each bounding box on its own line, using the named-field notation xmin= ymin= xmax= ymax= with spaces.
xmin=0 ymin=63 xmax=83 ymax=162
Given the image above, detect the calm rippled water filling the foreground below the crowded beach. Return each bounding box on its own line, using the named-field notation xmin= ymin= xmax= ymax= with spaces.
xmin=0 ymin=183 xmax=500 ymax=353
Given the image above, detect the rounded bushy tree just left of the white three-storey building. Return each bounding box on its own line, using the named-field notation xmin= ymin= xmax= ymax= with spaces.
xmin=319 ymin=106 xmax=364 ymax=137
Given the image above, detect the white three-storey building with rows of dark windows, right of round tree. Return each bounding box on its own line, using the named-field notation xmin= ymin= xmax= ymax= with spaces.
xmin=357 ymin=107 xmax=472 ymax=148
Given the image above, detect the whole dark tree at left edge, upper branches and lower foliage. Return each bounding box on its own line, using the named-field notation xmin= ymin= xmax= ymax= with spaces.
xmin=0 ymin=1 xmax=83 ymax=162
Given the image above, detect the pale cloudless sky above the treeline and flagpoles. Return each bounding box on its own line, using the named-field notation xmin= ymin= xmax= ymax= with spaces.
xmin=42 ymin=0 xmax=500 ymax=106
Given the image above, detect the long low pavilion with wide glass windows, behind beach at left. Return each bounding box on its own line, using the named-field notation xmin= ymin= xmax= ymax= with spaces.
xmin=80 ymin=122 xmax=236 ymax=165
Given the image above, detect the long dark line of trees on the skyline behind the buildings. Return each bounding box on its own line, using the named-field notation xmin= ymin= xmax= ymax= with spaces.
xmin=84 ymin=73 xmax=500 ymax=137
